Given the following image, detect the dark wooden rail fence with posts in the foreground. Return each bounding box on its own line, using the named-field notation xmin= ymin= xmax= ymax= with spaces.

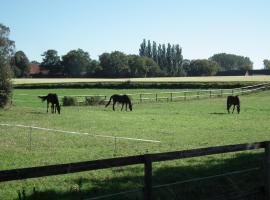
xmin=0 ymin=141 xmax=270 ymax=200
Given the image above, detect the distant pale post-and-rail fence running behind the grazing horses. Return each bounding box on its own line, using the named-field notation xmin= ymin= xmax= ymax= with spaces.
xmin=62 ymin=83 xmax=270 ymax=105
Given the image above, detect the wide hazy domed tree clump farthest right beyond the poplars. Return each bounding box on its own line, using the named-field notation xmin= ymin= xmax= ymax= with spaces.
xmin=209 ymin=53 xmax=253 ymax=71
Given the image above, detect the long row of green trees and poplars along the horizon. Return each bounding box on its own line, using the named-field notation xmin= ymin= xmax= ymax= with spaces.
xmin=11 ymin=39 xmax=270 ymax=78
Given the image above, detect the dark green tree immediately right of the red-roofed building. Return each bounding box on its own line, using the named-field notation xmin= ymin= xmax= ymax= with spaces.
xmin=40 ymin=49 xmax=64 ymax=74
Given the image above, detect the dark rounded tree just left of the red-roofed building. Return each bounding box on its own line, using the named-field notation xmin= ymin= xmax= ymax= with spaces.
xmin=11 ymin=51 xmax=30 ymax=77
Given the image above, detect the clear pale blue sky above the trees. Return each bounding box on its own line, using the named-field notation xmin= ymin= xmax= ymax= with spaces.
xmin=0 ymin=0 xmax=270 ymax=69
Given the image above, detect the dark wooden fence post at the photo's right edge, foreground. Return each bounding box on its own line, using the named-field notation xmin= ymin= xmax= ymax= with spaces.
xmin=264 ymin=141 xmax=270 ymax=200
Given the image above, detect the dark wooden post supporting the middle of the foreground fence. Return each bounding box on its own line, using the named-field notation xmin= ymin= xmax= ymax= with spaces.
xmin=144 ymin=154 xmax=152 ymax=200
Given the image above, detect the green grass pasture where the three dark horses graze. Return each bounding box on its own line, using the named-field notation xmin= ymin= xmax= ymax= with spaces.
xmin=0 ymin=89 xmax=270 ymax=199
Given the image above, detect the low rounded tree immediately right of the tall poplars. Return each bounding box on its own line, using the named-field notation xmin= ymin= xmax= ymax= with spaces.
xmin=187 ymin=59 xmax=219 ymax=76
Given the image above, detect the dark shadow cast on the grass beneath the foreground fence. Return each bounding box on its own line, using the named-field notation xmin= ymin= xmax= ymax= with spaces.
xmin=18 ymin=153 xmax=263 ymax=200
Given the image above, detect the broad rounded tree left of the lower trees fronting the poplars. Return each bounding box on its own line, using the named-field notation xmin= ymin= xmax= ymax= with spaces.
xmin=99 ymin=51 xmax=130 ymax=77
